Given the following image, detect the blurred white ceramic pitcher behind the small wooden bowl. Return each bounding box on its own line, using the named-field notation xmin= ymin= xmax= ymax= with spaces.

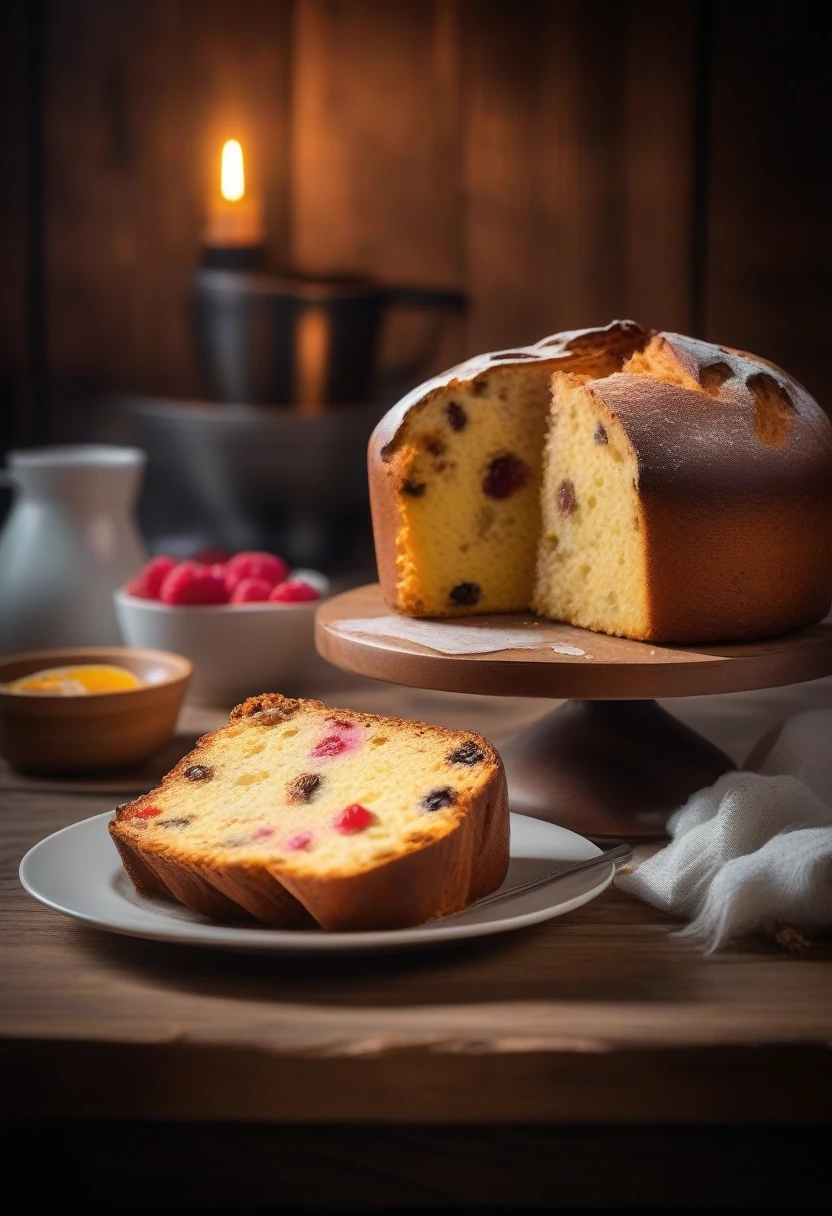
xmin=0 ymin=445 xmax=147 ymax=654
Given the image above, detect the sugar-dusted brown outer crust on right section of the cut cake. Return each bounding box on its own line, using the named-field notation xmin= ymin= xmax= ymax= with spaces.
xmin=589 ymin=334 xmax=832 ymax=642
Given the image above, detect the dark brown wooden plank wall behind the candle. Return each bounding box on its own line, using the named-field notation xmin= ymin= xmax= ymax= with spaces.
xmin=0 ymin=0 xmax=832 ymax=447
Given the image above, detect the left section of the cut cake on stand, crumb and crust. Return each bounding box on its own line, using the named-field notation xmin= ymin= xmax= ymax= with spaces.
xmin=369 ymin=321 xmax=647 ymax=617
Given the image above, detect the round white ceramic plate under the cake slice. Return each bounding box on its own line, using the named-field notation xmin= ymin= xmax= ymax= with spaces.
xmin=21 ymin=811 xmax=614 ymax=955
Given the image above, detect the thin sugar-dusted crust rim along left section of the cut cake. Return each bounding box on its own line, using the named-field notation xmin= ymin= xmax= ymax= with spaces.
xmin=367 ymin=321 xmax=648 ymax=614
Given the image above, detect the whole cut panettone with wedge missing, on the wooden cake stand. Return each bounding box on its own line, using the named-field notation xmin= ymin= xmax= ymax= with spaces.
xmin=370 ymin=322 xmax=832 ymax=643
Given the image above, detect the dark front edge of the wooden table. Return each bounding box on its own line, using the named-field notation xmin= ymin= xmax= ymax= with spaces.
xmin=0 ymin=1038 xmax=832 ymax=1126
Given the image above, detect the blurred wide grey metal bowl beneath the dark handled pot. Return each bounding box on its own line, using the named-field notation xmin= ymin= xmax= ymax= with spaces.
xmin=119 ymin=398 xmax=382 ymax=576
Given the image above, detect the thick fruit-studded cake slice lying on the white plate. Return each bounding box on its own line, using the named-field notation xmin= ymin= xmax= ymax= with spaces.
xmin=109 ymin=694 xmax=508 ymax=930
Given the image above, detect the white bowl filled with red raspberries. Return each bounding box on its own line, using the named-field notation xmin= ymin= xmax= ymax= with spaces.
xmin=116 ymin=550 xmax=328 ymax=706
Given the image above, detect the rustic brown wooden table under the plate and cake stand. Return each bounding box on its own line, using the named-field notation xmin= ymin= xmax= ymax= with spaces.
xmin=0 ymin=664 xmax=832 ymax=1204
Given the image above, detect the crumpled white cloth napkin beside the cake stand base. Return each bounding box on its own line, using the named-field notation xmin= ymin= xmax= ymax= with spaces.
xmin=617 ymin=709 xmax=832 ymax=952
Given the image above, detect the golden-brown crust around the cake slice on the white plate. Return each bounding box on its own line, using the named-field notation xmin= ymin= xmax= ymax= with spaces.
xmin=109 ymin=693 xmax=508 ymax=930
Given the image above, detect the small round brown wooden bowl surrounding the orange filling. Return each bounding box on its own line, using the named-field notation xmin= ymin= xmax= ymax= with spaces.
xmin=0 ymin=646 xmax=192 ymax=773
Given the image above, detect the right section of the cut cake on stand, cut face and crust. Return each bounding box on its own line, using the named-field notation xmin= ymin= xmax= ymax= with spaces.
xmin=533 ymin=333 xmax=832 ymax=643
